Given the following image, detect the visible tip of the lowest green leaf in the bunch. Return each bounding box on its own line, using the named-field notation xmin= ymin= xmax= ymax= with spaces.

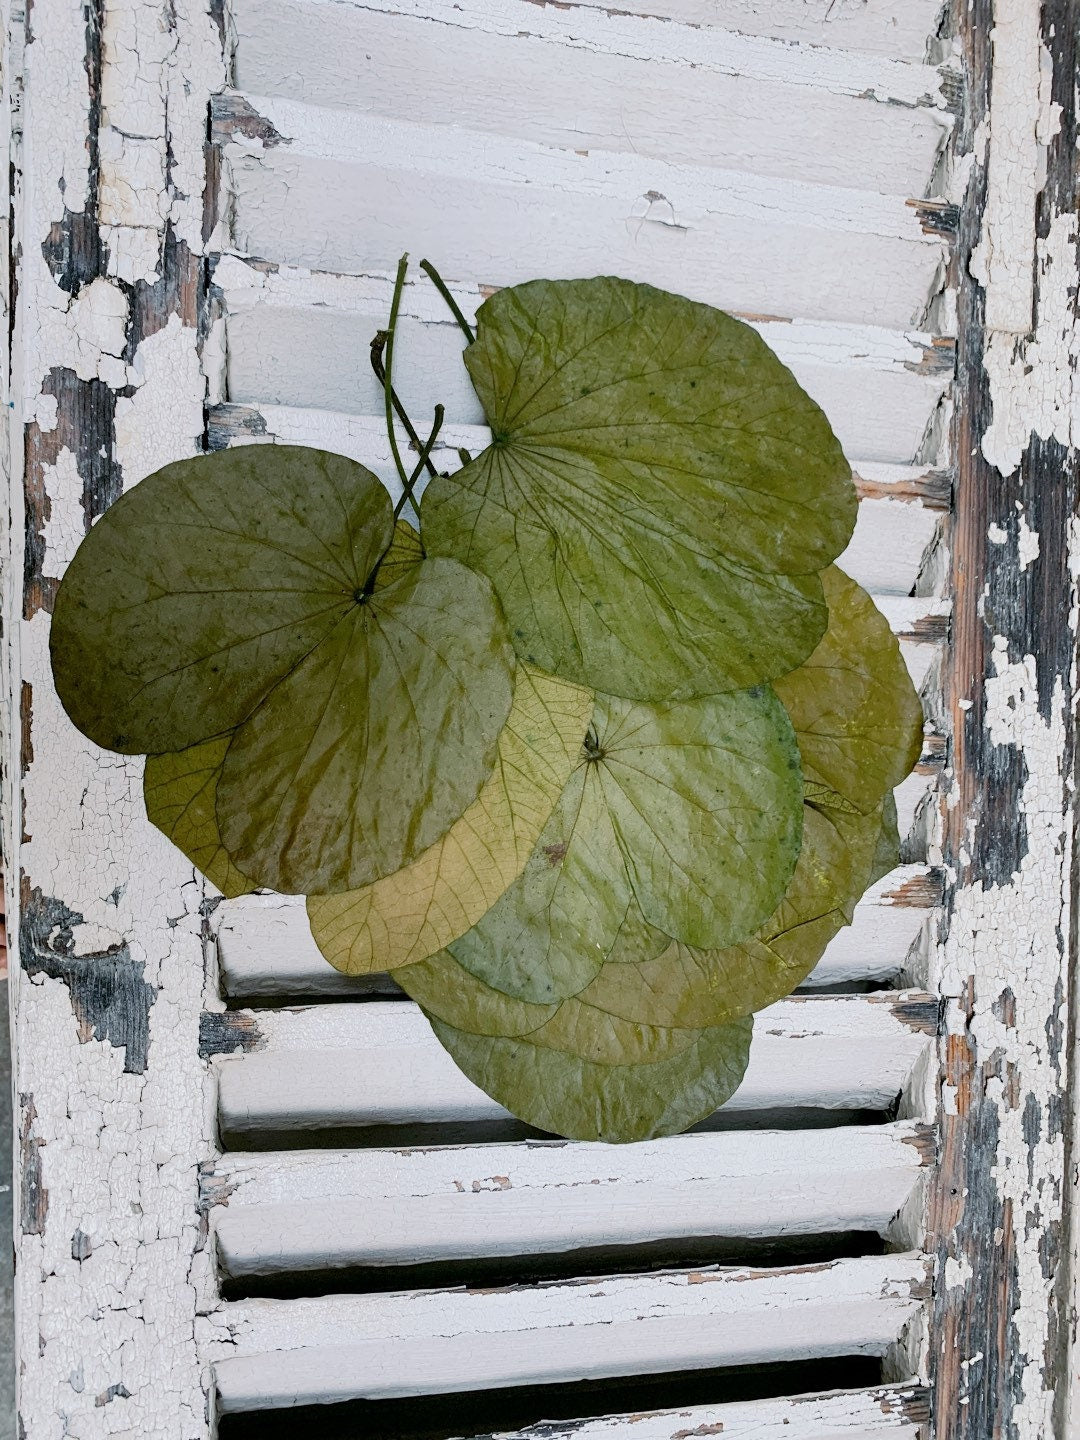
xmin=428 ymin=1015 xmax=753 ymax=1143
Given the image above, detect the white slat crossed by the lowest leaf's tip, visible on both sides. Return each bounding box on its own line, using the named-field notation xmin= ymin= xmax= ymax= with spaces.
xmin=217 ymin=994 xmax=936 ymax=1135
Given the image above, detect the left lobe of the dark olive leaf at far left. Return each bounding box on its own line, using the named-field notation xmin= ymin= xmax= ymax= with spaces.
xmin=50 ymin=445 xmax=393 ymax=755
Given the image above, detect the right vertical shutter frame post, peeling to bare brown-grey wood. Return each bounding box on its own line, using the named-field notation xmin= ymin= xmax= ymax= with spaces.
xmin=929 ymin=0 xmax=1080 ymax=1440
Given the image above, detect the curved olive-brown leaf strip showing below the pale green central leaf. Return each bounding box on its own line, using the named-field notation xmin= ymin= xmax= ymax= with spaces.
xmin=577 ymin=805 xmax=883 ymax=1027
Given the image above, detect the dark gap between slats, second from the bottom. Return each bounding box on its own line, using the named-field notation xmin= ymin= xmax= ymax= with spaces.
xmin=222 ymin=1230 xmax=886 ymax=1300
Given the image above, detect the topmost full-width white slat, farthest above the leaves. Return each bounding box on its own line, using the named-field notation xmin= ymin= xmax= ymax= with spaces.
xmin=235 ymin=0 xmax=952 ymax=197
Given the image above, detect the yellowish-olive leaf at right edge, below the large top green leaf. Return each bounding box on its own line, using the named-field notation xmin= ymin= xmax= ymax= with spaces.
xmin=773 ymin=566 xmax=923 ymax=815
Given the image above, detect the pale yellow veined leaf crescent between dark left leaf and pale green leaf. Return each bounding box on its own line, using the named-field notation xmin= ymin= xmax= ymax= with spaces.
xmin=308 ymin=668 xmax=593 ymax=975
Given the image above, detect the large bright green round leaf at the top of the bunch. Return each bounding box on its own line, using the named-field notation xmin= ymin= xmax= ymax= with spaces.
xmin=420 ymin=278 xmax=855 ymax=701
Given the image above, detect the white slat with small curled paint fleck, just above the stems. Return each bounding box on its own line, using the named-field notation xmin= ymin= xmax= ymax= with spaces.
xmin=217 ymin=96 xmax=945 ymax=330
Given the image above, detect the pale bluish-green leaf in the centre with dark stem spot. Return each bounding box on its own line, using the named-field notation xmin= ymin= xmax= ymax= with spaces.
xmin=451 ymin=687 xmax=802 ymax=1004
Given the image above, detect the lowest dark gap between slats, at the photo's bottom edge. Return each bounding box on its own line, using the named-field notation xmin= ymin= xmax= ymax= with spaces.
xmin=217 ymin=1355 xmax=881 ymax=1440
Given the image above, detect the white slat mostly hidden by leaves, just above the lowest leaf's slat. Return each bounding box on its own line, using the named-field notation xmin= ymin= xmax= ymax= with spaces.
xmin=217 ymin=865 xmax=940 ymax=999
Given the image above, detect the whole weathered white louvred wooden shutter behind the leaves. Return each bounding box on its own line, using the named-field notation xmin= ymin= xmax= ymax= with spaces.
xmin=3 ymin=0 xmax=1079 ymax=1440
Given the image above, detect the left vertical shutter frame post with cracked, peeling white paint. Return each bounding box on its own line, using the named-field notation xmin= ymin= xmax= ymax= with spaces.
xmin=3 ymin=0 xmax=223 ymax=1440
